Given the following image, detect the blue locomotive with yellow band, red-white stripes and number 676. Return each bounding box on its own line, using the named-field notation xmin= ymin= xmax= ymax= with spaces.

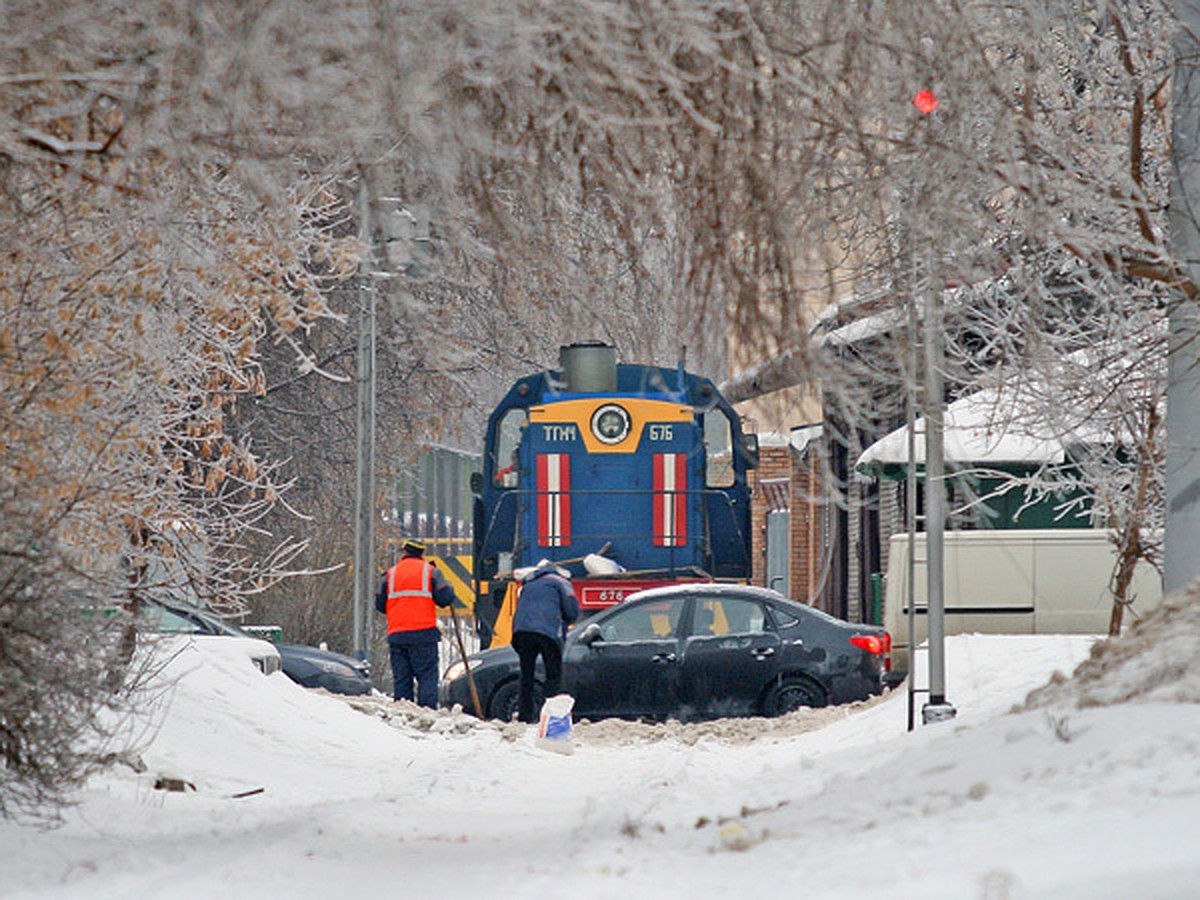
xmin=472 ymin=342 xmax=757 ymax=647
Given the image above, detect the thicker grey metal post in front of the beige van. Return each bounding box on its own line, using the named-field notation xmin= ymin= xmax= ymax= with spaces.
xmin=908 ymin=283 xmax=955 ymax=725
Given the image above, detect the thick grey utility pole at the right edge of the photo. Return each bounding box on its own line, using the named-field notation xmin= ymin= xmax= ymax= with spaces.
xmin=1163 ymin=0 xmax=1200 ymax=594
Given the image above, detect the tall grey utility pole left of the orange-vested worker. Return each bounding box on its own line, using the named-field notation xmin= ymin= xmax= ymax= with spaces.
xmin=354 ymin=173 xmax=376 ymax=659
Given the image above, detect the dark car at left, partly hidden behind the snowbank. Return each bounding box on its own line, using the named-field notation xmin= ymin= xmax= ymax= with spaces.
xmin=142 ymin=602 xmax=372 ymax=695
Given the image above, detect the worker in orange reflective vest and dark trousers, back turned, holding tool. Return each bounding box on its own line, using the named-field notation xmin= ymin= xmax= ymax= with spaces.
xmin=376 ymin=540 xmax=455 ymax=707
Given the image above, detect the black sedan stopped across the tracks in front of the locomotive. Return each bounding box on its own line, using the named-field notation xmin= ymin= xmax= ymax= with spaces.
xmin=439 ymin=584 xmax=890 ymax=721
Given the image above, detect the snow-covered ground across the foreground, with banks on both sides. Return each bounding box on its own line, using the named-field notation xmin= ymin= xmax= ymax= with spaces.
xmin=0 ymin=592 xmax=1200 ymax=900
